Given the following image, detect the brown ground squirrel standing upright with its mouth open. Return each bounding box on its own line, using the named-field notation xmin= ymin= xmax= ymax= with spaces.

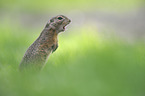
xmin=19 ymin=15 xmax=71 ymax=70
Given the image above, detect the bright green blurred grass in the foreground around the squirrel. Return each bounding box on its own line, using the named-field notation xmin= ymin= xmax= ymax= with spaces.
xmin=0 ymin=27 xmax=145 ymax=96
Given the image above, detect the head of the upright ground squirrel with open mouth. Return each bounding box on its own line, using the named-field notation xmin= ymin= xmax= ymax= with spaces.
xmin=46 ymin=15 xmax=71 ymax=33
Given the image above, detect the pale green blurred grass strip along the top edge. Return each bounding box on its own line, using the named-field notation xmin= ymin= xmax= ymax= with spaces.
xmin=0 ymin=0 xmax=144 ymax=13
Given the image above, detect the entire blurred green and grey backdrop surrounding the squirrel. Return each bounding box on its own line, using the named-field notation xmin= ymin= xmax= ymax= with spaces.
xmin=0 ymin=0 xmax=145 ymax=96
